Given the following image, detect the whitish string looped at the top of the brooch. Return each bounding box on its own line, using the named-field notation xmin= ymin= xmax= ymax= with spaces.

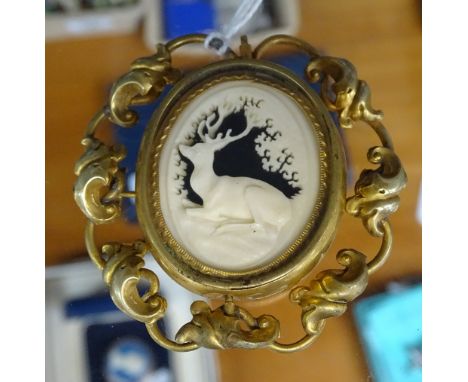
xmin=205 ymin=0 xmax=263 ymax=56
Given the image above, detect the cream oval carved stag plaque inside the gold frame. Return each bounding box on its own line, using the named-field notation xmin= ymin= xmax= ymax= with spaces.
xmin=159 ymin=81 xmax=320 ymax=271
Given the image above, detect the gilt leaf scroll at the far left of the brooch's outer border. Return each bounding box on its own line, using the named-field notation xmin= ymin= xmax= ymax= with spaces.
xmin=74 ymin=137 xmax=125 ymax=224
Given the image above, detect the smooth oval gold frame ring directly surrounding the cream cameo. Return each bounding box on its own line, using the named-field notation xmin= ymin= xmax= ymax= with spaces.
xmin=136 ymin=62 xmax=345 ymax=298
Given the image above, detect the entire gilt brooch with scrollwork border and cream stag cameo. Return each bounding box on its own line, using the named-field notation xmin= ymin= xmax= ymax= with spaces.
xmin=74 ymin=34 xmax=406 ymax=352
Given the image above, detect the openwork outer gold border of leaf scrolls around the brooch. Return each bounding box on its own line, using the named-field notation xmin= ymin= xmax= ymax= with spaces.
xmin=74 ymin=34 xmax=406 ymax=353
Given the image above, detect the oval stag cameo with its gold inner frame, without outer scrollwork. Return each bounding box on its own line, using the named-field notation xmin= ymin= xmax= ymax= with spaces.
xmin=137 ymin=60 xmax=344 ymax=297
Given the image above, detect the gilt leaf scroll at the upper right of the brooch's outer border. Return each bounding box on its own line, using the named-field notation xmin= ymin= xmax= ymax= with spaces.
xmin=306 ymin=57 xmax=383 ymax=128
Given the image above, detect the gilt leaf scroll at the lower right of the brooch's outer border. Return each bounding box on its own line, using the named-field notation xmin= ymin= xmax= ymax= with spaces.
xmin=289 ymin=249 xmax=368 ymax=335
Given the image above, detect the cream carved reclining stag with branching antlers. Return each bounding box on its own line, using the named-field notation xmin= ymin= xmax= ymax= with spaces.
xmin=179 ymin=102 xmax=291 ymax=232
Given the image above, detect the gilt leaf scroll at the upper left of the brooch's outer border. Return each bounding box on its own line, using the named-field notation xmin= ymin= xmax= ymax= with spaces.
xmin=109 ymin=44 xmax=180 ymax=127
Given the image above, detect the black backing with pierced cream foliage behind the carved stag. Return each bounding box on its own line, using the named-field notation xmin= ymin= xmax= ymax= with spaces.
xmin=175 ymin=97 xmax=302 ymax=205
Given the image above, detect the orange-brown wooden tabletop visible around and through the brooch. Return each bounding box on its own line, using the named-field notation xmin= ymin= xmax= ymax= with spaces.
xmin=46 ymin=0 xmax=421 ymax=382
